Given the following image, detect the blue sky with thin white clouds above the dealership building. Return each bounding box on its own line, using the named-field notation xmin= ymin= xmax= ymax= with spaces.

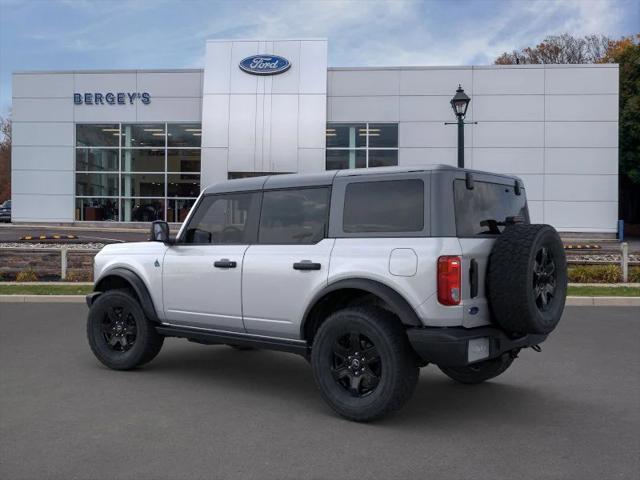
xmin=0 ymin=0 xmax=640 ymax=115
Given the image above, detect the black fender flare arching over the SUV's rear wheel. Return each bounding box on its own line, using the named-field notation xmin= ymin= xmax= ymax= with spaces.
xmin=300 ymin=278 xmax=423 ymax=338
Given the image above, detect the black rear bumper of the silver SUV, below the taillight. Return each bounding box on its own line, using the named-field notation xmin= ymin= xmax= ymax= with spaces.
xmin=407 ymin=327 xmax=547 ymax=367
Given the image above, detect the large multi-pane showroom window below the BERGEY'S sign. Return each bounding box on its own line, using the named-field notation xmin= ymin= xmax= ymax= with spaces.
xmin=75 ymin=123 xmax=202 ymax=222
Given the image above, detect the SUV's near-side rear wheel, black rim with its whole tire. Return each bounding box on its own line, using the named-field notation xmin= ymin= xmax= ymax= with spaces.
xmin=311 ymin=306 xmax=419 ymax=422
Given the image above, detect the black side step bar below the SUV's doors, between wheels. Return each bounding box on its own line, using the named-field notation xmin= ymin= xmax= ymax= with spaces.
xmin=156 ymin=325 xmax=310 ymax=357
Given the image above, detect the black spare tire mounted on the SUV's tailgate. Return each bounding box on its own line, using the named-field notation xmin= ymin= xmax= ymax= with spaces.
xmin=487 ymin=224 xmax=567 ymax=335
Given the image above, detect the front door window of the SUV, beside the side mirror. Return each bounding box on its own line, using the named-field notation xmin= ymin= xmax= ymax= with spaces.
xmin=184 ymin=193 xmax=260 ymax=244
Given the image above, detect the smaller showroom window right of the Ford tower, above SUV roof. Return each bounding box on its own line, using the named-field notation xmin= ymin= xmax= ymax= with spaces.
xmin=326 ymin=123 xmax=398 ymax=170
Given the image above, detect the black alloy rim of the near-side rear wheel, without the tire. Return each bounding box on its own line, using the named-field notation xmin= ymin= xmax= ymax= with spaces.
xmin=331 ymin=332 xmax=382 ymax=397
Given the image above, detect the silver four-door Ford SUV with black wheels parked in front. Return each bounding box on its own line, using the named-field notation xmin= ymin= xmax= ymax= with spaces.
xmin=87 ymin=165 xmax=567 ymax=421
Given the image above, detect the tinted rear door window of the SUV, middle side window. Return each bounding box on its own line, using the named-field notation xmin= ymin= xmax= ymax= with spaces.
xmin=258 ymin=187 xmax=330 ymax=244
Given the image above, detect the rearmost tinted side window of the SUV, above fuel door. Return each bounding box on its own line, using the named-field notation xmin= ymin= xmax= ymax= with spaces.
xmin=342 ymin=179 xmax=424 ymax=233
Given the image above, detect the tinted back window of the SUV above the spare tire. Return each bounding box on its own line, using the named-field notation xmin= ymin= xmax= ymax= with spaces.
xmin=453 ymin=180 xmax=529 ymax=237
